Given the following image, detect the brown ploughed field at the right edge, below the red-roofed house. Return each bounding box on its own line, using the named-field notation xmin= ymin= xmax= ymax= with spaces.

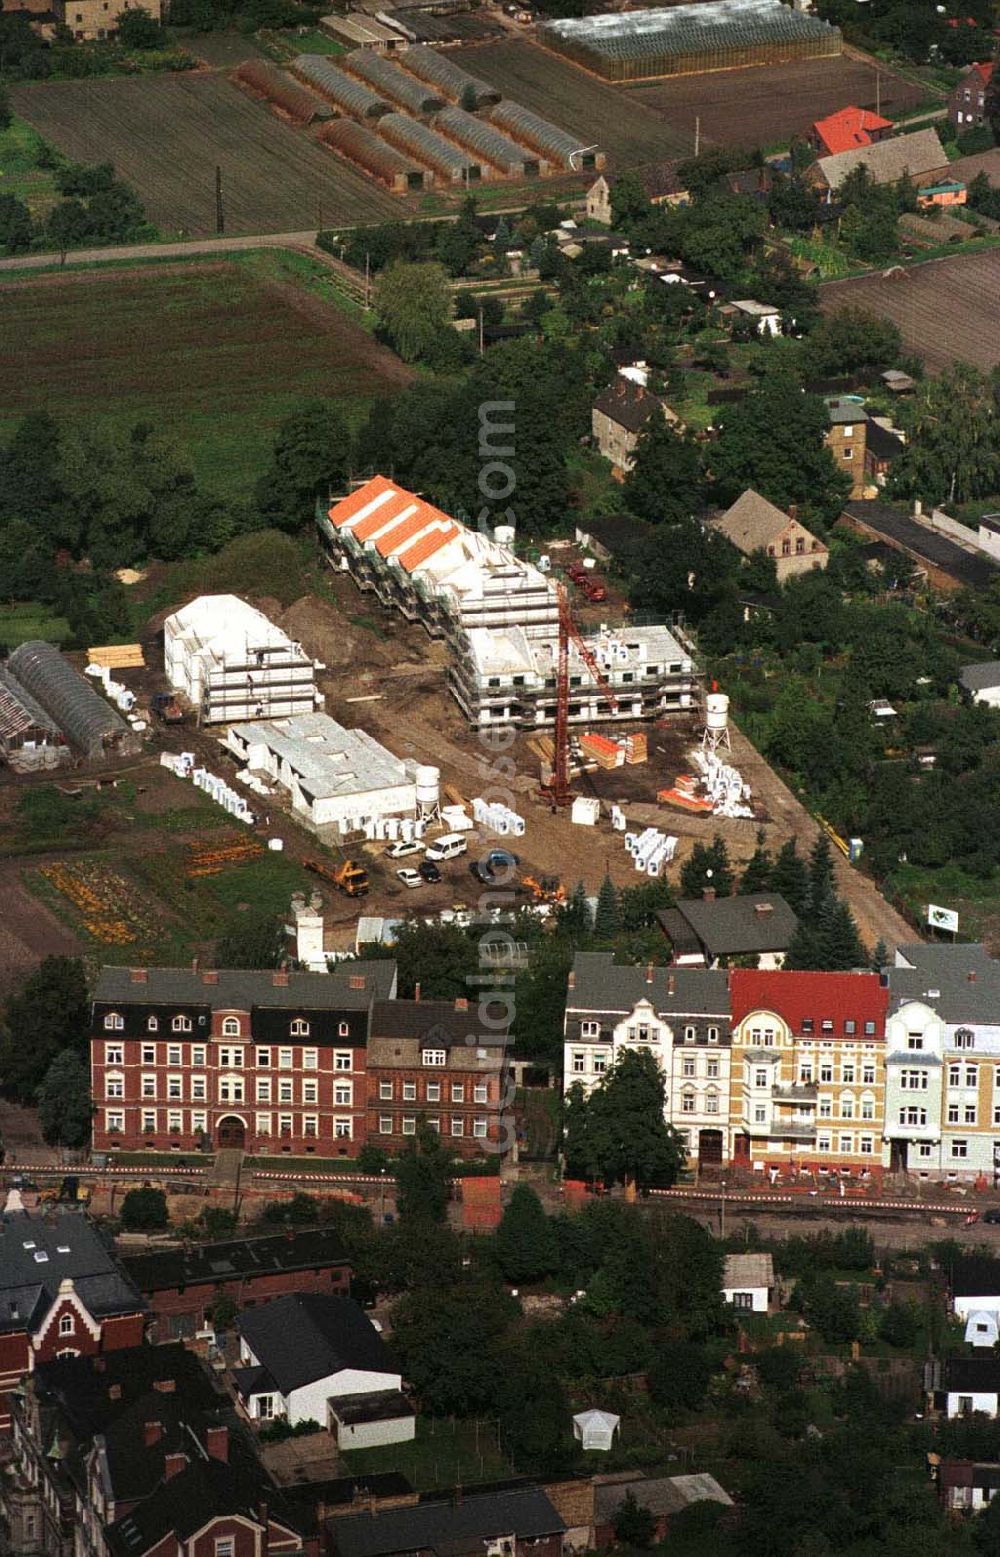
xmin=819 ymin=248 xmax=1000 ymax=372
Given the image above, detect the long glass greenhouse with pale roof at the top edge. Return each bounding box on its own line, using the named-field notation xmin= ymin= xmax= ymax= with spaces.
xmin=539 ymin=0 xmax=843 ymax=81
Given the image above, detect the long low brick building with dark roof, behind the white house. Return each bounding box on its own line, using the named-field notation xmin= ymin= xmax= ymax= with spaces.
xmin=121 ymin=1227 xmax=350 ymax=1342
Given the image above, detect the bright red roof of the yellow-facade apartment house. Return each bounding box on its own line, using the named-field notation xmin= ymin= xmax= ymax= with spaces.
xmin=729 ymin=968 xmax=889 ymax=1039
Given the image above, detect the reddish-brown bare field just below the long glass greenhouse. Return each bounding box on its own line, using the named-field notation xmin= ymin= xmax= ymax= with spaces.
xmin=628 ymin=54 xmax=925 ymax=153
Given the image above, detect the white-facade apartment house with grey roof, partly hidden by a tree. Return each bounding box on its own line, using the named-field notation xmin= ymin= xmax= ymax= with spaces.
xmin=562 ymin=951 xmax=732 ymax=1165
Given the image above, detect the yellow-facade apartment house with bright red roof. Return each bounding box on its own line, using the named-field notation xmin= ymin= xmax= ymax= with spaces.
xmin=729 ymin=968 xmax=888 ymax=1180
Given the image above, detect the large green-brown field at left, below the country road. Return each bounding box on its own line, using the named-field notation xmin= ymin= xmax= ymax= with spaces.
xmin=0 ymin=251 xmax=411 ymax=495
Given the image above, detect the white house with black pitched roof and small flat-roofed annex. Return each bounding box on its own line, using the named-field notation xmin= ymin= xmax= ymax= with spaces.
xmin=232 ymin=1292 xmax=416 ymax=1450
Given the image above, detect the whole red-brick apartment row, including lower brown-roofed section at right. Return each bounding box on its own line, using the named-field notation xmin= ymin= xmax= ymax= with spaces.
xmin=90 ymin=961 xmax=506 ymax=1157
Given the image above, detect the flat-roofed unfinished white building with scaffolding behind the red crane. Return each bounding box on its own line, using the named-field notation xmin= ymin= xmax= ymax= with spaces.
xmin=449 ymin=624 xmax=699 ymax=730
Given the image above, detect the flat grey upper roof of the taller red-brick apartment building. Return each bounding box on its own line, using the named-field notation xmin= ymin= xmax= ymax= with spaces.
xmin=93 ymin=959 xmax=396 ymax=1010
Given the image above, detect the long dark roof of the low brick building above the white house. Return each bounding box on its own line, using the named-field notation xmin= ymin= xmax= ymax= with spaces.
xmin=121 ymin=1227 xmax=347 ymax=1292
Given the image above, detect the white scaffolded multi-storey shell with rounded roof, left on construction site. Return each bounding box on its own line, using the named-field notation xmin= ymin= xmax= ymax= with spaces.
xmin=164 ymin=595 xmax=324 ymax=724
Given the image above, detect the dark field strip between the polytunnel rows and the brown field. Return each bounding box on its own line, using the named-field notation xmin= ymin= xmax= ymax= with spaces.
xmin=449 ymin=37 xmax=690 ymax=168
